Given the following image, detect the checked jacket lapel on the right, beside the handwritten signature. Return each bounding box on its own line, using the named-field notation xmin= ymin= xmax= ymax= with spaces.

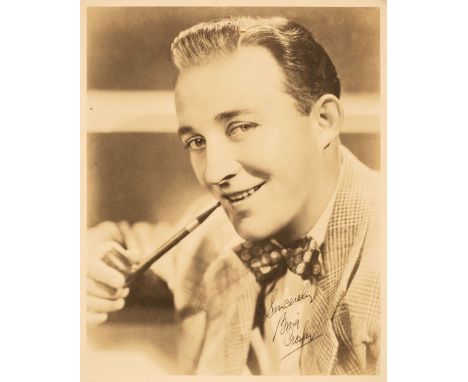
xmin=301 ymin=148 xmax=368 ymax=375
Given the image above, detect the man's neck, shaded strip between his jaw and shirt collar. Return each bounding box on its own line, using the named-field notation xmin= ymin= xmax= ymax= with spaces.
xmin=275 ymin=147 xmax=341 ymax=246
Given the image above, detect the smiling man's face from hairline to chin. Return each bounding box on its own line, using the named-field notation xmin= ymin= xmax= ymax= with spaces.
xmin=176 ymin=47 xmax=326 ymax=240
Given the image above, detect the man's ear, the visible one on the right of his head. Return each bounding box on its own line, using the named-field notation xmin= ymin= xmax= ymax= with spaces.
xmin=312 ymin=94 xmax=344 ymax=149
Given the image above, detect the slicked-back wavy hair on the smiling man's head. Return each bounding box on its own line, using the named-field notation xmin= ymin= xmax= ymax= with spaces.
xmin=171 ymin=17 xmax=340 ymax=115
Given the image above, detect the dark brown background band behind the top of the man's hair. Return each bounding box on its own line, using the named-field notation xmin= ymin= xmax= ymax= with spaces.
xmin=87 ymin=7 xmax=380 ymax=92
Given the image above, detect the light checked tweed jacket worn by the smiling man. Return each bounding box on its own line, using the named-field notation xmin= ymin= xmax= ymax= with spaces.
xmin=132 ymin=147 xmax=383 ymax=375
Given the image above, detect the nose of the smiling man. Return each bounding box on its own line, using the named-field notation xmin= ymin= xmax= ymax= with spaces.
xmin=204 ymin=138 xmax=241 ymax=186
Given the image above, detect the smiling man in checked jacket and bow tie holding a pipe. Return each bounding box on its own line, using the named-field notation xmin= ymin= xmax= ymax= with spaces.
xmin=88 ymin=17 xmax=381 ymax=374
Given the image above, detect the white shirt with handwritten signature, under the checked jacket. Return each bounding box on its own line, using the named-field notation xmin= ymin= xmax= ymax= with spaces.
xmin=246 ymin=186 xmax=336 ymax=375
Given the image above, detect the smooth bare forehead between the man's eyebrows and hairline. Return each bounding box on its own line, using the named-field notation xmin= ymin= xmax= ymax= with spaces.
xmin=175 ymin=46 xmax=293 ymax=123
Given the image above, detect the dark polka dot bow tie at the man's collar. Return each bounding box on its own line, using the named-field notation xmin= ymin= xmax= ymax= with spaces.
xmin=234 ymin=236 xmax=324 ymax=285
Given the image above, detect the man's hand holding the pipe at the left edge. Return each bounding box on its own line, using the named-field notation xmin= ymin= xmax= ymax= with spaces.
xmin=86 ymin=222 xmax=140 ymax=326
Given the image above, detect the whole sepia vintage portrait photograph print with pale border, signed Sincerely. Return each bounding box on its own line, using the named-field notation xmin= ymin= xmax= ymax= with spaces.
xmin=81 ymin=1 xmax=386 ymax=381
